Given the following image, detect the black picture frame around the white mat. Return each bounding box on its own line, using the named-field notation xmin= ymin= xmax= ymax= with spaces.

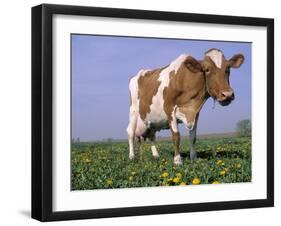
xmin=32 ymin=4 xmax=274 ymax=221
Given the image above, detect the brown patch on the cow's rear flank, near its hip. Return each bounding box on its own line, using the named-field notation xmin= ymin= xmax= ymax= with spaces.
xmin=138 ymin=68 xmax=164 ymax=120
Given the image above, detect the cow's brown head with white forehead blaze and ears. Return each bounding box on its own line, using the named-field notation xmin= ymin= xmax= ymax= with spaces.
xmin=201 ymin=49 xmax=244 ymax=106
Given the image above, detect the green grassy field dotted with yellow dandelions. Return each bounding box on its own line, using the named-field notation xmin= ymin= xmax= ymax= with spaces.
xmin=71 ymin=137 xmax=251 ymax=190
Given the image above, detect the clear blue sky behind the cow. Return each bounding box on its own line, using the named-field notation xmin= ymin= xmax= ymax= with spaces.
xmin=71 ymin=35 xmax=251 ymax=141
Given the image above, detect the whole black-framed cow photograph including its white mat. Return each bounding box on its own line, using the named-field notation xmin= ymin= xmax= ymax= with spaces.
xmin=32 ymin=4 xmax=274 ymax=221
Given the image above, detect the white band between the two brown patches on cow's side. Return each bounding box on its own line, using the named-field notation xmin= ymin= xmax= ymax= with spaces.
xmin=146 ymin=54 xmax=189 ymax=123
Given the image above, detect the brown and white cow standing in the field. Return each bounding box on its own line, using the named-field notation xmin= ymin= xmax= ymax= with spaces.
xmin=127 ymin=48 xmax=244 ymax=165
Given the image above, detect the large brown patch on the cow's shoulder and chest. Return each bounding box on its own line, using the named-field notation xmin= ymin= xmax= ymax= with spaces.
xmin=163 ymin=58 xmax=206 ymax=126
